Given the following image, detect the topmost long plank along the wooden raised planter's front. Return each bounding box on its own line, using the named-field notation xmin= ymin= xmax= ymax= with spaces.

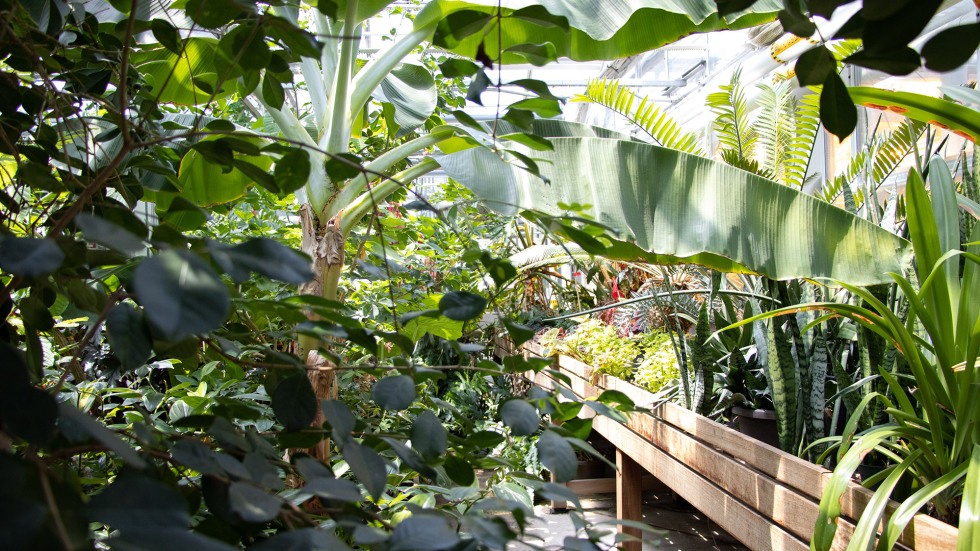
xmin=530 ymin=345 xmax=958 ymax=549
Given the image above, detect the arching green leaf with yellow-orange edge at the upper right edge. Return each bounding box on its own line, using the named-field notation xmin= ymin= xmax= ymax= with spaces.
xmin=847 ymin=86 xmax=980 ymax=143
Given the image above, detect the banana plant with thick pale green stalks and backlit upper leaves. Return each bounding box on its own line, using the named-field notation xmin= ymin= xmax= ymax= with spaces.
xmin=117 ymin=0 xmax=788 ymax=462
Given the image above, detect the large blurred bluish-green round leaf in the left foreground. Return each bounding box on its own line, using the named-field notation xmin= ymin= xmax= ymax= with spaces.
xmin=133 ymin=251 xmax=231 ymax=341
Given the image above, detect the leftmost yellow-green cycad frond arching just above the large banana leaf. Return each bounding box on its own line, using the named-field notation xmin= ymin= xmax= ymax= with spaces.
xmin=572 ymin=79 xmax=704 ymax=155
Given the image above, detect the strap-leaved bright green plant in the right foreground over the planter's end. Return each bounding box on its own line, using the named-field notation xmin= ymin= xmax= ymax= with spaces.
xmin=724 ymin=158 xmax=980 ymax=550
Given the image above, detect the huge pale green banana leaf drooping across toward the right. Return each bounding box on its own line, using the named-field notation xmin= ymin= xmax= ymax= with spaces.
xmin=439 ymin=121 xmax=911 ymax=285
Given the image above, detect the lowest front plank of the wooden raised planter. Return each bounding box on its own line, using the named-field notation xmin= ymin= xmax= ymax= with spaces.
xmin=593 ymin=417 xmax=808 ymax=551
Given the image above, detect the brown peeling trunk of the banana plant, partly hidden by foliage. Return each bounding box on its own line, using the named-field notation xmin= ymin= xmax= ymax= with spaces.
xmin=298 ymin=204 xmax=345 ymax=463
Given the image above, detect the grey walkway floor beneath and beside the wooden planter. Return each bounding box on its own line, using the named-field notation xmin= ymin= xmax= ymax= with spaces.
xmin=508 ymin=492 xmax=748 ymax=551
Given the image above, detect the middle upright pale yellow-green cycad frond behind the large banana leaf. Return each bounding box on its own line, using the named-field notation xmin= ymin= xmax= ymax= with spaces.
xmin=755 ymin=81 xmax=796 ymax=182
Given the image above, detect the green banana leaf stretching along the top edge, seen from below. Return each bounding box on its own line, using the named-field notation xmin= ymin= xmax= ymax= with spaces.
xmin=415 ymin=0 xmax=783 ymax=63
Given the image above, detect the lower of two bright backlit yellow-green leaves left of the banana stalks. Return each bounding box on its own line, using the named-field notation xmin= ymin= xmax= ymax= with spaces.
xmin=177 ymin=138 xmax=278 ymax=206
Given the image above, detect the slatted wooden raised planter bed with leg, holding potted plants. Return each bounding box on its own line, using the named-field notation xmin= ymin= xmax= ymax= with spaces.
xmin=497 ymin=342 xmax=958 ymax=551
